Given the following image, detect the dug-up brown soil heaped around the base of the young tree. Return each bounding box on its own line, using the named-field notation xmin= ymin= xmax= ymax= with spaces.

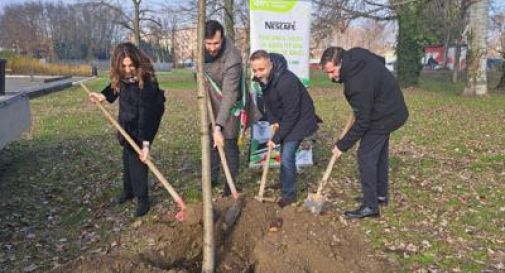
xmin=52 ymin=199 xmax=394 ymax=273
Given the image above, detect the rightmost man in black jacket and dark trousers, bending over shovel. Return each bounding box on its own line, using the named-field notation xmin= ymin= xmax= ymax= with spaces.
xmin=321 ymin=47 xmax=409 ymax=218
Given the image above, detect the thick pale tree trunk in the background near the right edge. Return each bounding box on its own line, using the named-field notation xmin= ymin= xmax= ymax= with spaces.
xmin=462 ymin=0 xmax=489 ymax=96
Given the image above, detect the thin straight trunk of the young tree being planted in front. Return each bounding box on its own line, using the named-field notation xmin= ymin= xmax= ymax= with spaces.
xmin=197 ymin=0 xmax=215 ymax=273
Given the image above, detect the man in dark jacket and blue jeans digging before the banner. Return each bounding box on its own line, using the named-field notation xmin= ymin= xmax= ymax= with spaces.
xmin=250 ymin=50 xmax=318 ymax=207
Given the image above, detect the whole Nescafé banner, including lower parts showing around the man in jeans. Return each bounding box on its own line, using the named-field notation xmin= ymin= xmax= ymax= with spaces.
xmin=249 ymin=0 xmax=313 ymax=168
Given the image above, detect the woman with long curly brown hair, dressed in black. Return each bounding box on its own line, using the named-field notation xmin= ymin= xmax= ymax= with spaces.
xmin=89 ymin=43 xmax=165 ymax=217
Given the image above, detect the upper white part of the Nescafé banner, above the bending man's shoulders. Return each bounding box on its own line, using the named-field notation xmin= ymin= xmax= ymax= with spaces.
xmin=249 ymin=0 xmax=311 ymax=86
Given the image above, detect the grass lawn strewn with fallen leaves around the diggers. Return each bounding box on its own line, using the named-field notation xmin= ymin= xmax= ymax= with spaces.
xmin=0 ymin=70 xmax=505 ymax=272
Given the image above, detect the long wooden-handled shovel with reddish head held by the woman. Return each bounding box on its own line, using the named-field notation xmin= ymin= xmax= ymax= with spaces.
xmin=80 ymin=82 xmax=186 ymax=222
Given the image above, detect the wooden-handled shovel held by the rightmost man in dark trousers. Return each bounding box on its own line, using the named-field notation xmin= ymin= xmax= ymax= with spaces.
xmin=305 ymin=115 xmax=354 ymax=215
